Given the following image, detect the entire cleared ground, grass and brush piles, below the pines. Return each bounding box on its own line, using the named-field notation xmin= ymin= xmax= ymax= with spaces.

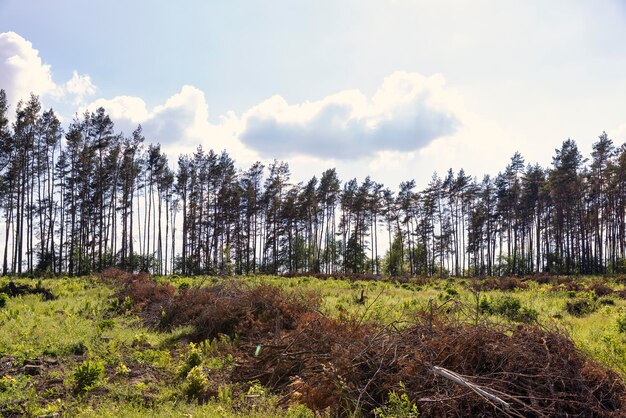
xmin=0 ymin=270 xmax=626 ymax=417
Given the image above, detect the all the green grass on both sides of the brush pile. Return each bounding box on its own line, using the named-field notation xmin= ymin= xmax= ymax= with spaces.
xmin=0 ymin=276 xmax=626 ymax=417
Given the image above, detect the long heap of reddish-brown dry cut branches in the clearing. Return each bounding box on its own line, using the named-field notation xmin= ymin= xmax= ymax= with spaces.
xmin=112 ymin=272 xmax=626 ymax=417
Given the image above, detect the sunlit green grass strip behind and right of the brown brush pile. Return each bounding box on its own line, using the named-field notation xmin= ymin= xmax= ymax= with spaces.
xmin=176 ymin=276 xmax=626 ymax=376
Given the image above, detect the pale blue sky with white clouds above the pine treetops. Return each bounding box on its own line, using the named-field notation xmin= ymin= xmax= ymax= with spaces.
xmin=0 ymin=0 xmax=626 ymax=188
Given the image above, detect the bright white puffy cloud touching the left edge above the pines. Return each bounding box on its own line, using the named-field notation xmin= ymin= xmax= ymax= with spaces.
xmin=0 ymin=32 xmax=58 ymax=103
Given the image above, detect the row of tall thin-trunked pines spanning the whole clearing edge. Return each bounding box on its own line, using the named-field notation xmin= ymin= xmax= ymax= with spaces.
xmin=0 ymin=90 xmax=626 ymax=276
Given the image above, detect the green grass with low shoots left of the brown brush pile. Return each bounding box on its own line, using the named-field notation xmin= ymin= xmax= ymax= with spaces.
xmin=0 ymin=278 xmax=316 ymax=417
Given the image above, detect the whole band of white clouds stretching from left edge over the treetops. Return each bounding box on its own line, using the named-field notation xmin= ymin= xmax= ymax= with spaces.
xmin=0 ymin=33 xmax=525 ymax=185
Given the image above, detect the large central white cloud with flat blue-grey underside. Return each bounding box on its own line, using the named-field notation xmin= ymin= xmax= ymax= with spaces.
xmin=240 ymin=72 xmax=460 ymax=159
